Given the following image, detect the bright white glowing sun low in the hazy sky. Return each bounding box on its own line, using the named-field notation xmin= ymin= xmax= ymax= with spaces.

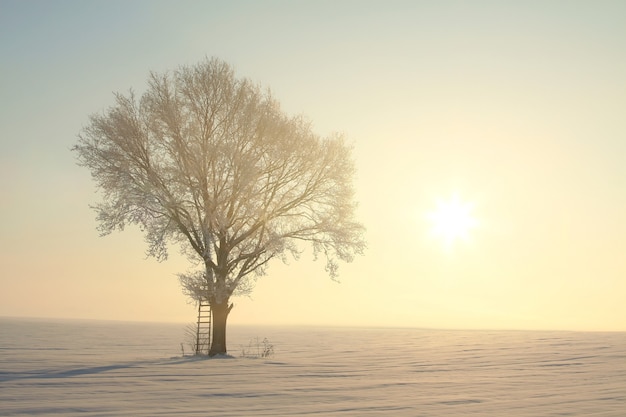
xmin=428 ymin=195 xmax=478 ymax=248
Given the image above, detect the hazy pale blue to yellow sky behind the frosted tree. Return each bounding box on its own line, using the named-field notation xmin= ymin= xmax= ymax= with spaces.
xmin=0 ymin=0 xmax=626 ymax=331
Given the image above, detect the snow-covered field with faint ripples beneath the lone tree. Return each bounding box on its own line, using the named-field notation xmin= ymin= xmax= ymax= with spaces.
xmin=0 ymin=319 xmax=626 ymax=417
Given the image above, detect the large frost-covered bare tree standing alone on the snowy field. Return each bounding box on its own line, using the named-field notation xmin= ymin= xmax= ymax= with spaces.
xmin=72 ymin=58 xmax=365 ymax=355
